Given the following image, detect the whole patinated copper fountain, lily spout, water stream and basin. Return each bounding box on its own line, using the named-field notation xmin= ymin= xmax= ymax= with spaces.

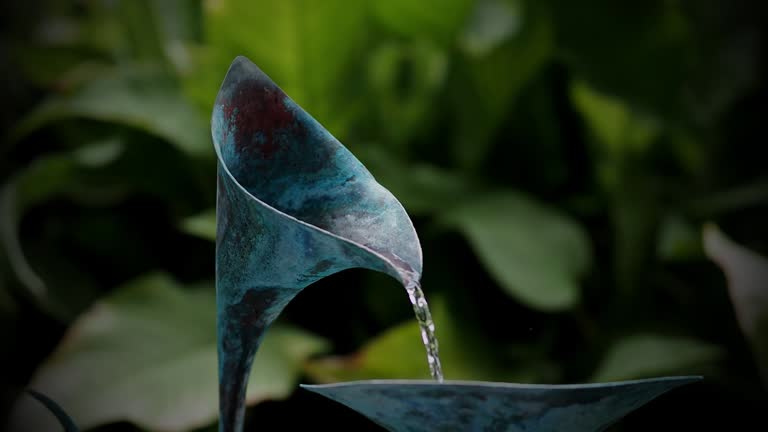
xmin=212 ymin=57 xmax=700 ymax=432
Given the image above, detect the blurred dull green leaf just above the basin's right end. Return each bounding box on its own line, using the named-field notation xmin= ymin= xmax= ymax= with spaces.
xmin=592 ymin=334 xmax=723 ymax=382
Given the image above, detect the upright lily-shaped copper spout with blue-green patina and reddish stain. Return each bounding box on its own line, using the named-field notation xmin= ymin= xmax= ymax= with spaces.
xmin=211 ymin=57 xmax=422 ymax=431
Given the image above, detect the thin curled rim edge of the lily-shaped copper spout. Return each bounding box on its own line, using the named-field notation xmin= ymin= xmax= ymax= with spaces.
xmin=211 ymin=56 xmax=424 ymax=283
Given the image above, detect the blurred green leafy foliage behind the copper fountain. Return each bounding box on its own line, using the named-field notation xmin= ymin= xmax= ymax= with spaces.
xmin=0 ymin=0 xmax=768 ymax=431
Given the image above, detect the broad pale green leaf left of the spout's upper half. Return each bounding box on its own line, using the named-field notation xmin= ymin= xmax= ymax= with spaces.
xmin=14 ymin=71 xmax=213 ymax=155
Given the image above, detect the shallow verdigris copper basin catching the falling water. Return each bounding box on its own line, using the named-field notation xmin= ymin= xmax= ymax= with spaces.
xmin=303 ymin=377 xmax=700 ymax=432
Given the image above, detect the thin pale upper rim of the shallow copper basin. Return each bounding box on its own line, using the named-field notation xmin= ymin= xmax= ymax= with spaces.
xmin=299 ymin=375 xmax=704 ymax=392
